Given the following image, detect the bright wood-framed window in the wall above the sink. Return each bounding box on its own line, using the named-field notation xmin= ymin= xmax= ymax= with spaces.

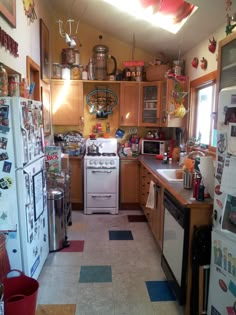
xmin=189 ymin=71 xmax=217 ymax=151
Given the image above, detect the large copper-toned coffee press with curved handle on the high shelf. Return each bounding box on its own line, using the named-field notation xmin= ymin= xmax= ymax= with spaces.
xmin=93 ymin=36 xmax=117 ymax=80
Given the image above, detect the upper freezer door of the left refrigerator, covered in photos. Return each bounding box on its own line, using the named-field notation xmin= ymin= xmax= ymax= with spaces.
xmin=9 ymin=97 xmax=44 ymax=168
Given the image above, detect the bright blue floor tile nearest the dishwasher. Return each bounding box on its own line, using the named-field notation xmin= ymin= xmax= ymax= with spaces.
xmin=146 ymin=281 xmax=176 ymax=302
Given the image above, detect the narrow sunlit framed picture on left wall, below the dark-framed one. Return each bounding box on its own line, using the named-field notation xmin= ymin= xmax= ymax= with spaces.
xmin=41 ymin=83 xmax=51 ymax=136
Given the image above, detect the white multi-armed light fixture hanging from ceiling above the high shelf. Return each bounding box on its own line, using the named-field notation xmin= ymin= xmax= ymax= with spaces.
xmin=57 ymin=19 xmax=79 ymax=48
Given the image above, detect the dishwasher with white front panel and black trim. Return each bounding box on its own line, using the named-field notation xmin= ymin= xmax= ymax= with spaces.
xmin=161 ymin=190 xmax=190 ymax=305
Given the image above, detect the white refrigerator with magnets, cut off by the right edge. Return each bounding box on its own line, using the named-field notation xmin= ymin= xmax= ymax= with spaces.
xmin=207 ymin=86 xmax=236 ymax=315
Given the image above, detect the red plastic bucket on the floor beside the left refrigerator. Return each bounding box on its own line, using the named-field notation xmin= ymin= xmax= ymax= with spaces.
xmin=3 ymin=270 xmax=39 ymax=315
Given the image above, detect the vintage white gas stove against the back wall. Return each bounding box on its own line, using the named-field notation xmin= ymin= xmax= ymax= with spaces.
xmin=84 ymin=138 xmax=119 ymax=214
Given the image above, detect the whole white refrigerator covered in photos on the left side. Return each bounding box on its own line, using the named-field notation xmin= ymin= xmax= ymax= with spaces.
xmin=0 ymin=97 xmax=49 ymax=279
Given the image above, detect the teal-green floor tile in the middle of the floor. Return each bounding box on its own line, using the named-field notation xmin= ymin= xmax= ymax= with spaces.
xmin=79 ymin=266 xmax=112 ymax=283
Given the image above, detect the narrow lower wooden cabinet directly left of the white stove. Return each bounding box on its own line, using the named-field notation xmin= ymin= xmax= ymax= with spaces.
xmin=70 ymin=157 xmax=83 ymax=210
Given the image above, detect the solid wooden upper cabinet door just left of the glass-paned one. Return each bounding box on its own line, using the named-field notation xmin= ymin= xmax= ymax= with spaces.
xmin=120 ymin=82 xmax=140 ymax=126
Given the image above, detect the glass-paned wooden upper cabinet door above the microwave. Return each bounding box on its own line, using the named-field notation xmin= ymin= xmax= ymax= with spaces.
xmin=139 ymin=82 xmax=161 ymax=127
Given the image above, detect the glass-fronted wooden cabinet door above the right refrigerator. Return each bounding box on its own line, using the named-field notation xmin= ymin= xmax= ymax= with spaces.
xmin=218 ymin=33 xmax=236 ymax=91
